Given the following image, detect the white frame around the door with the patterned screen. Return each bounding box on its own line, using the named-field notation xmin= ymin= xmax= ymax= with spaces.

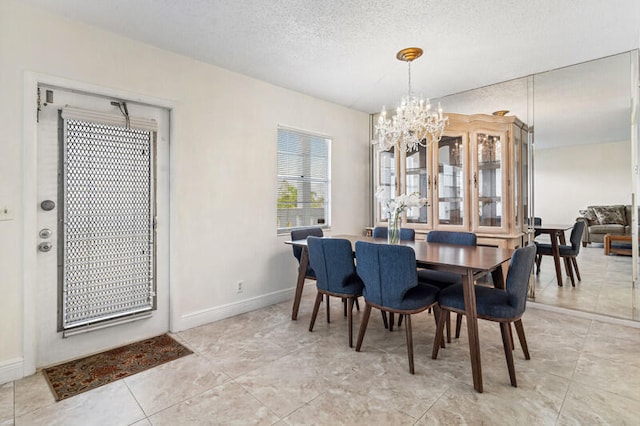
xmin=22 ymin=71 xmax=179 ymax=377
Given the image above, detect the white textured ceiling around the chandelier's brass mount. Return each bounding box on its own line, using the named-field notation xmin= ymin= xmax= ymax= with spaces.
xmin=23 ymin=0 xmax=640 ymax=148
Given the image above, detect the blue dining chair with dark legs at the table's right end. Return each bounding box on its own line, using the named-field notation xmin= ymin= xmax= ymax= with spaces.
xmin=432 ymin=243 xmax=536 ymax=387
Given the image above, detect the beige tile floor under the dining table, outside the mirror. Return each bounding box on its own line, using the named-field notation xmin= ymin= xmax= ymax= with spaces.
xmin=0 ymin=278 xmax=640 ymax=426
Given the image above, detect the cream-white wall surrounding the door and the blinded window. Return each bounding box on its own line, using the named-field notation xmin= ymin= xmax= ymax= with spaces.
xmin=0 ymin=0 xmax=370 ymax=383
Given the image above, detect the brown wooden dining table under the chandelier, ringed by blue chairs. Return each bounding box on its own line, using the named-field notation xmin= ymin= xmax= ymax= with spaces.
xmin=286 ymin=235 xmax=513 ymax=392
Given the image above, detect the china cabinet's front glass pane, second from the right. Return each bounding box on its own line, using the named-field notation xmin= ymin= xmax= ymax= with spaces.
xmin=434 ymin=136 xmax=466 ymax=226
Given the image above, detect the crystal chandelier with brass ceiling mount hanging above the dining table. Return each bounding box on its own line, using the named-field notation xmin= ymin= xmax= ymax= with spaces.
xmin=372 ymin=47 xmax=449 ymax=151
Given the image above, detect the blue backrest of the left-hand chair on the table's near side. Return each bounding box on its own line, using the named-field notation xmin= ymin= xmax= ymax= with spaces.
xmin=307 ymin=236 xmax=362 ymax=294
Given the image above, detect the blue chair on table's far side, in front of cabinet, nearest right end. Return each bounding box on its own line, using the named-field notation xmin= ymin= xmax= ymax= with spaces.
xmin=418 ymin=231 xmax=478 ymax=343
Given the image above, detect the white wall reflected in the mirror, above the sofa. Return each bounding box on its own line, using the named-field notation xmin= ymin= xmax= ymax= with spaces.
xmin=534 ymin=142 xmax=632 ymax=224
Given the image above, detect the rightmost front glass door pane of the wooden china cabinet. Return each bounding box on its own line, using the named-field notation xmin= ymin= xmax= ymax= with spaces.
xmin=474 ymin=132 xmax=505 ymax=230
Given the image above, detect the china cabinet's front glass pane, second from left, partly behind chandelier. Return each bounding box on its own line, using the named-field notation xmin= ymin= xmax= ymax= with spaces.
xmin=405 ymin=146 xmax=430 ymax=224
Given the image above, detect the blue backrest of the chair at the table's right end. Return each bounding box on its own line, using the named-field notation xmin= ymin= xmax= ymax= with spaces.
xmin=505 ymin=243 xmax=536 ymax=315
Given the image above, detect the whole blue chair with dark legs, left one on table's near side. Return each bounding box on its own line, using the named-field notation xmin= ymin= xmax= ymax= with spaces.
xmin=307 ymin=236 xmax=363 ymax=347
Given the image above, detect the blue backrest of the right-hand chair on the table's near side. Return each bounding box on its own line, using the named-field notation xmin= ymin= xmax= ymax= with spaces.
xmin=356 ymin=241 xmax=418 ymax=308
